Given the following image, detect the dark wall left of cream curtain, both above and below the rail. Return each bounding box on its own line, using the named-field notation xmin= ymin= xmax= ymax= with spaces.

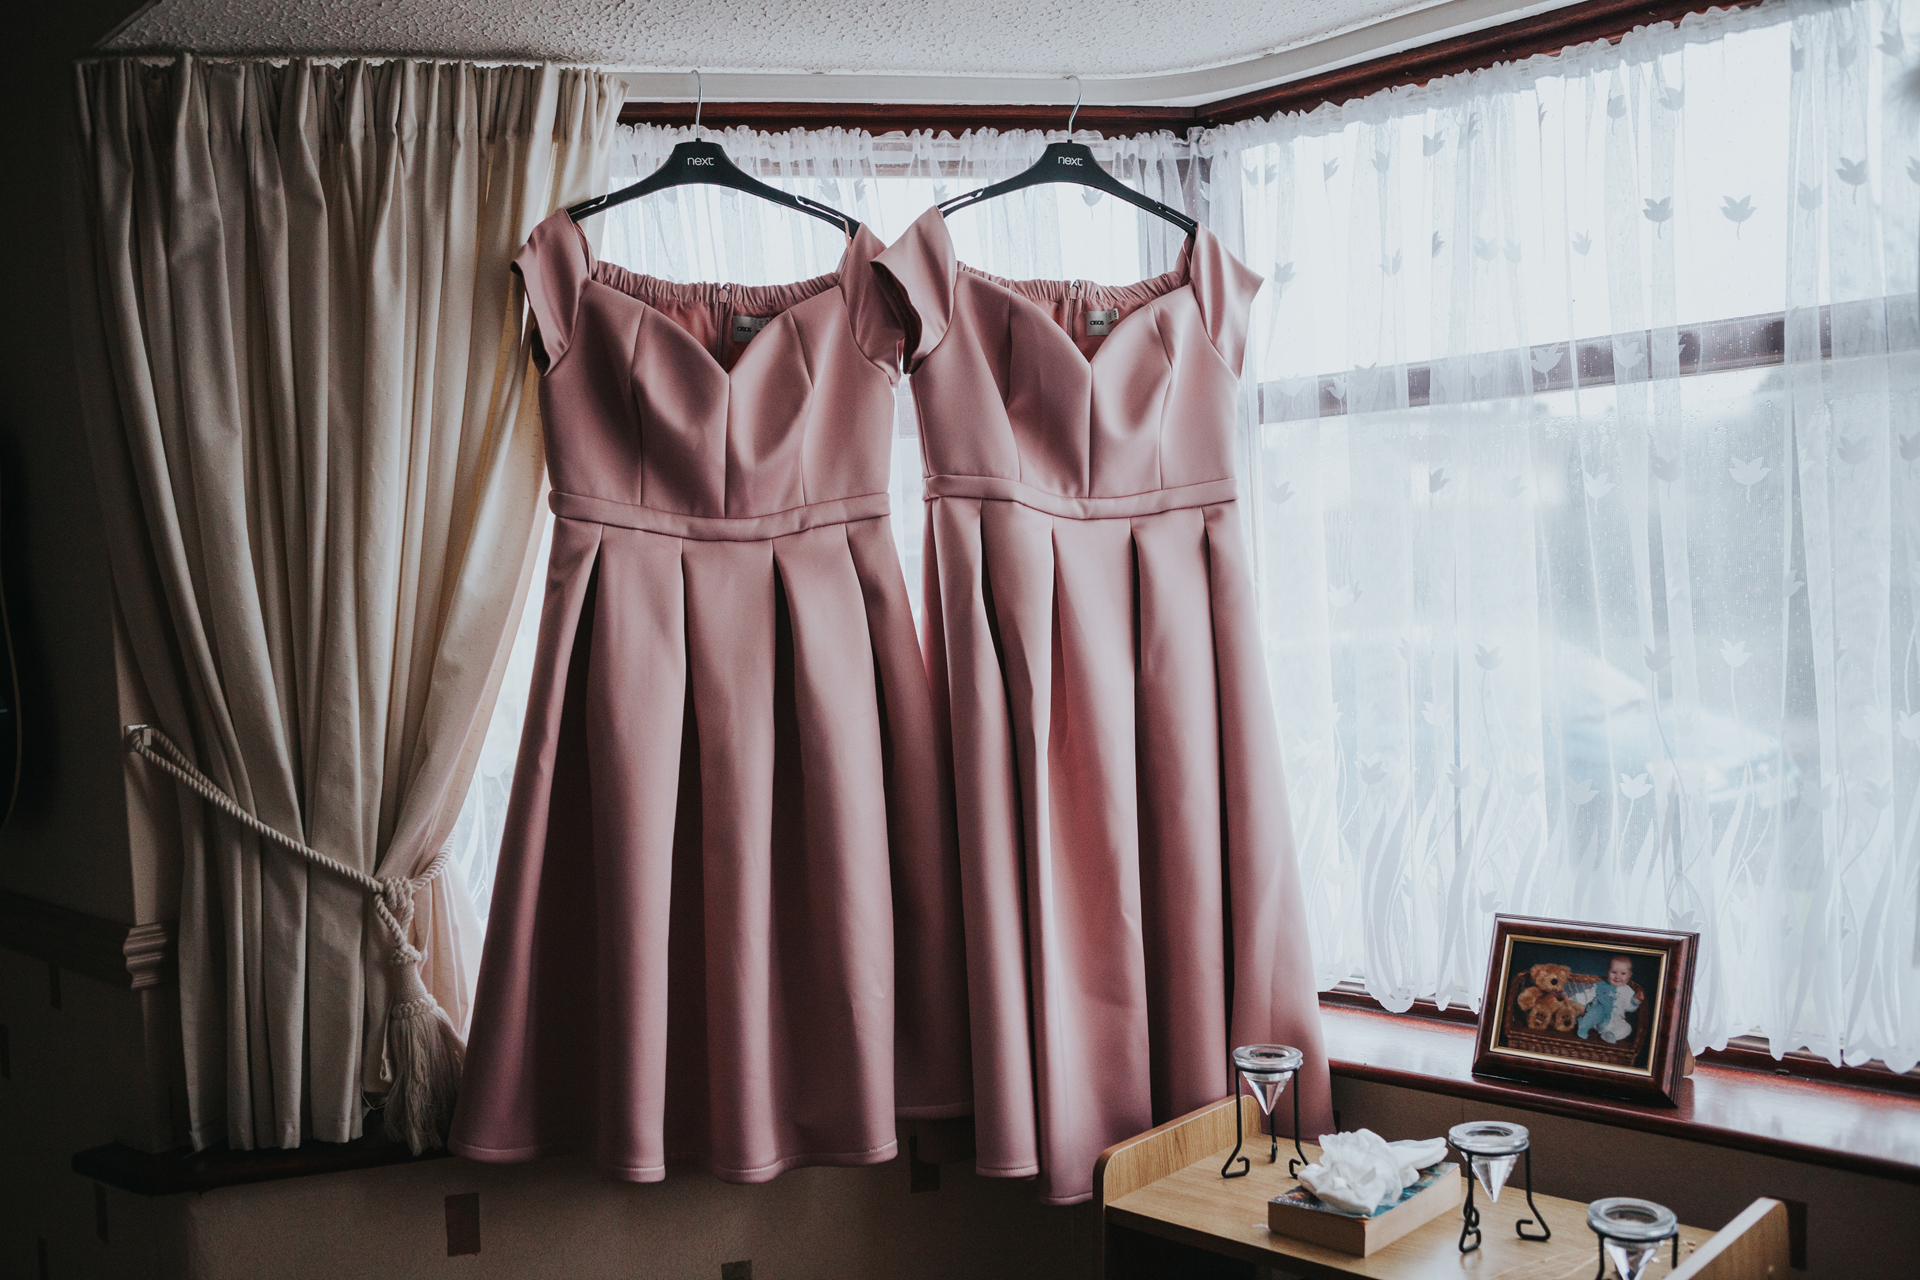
xmin=0 ymin=0 xmax=192 ymax=1280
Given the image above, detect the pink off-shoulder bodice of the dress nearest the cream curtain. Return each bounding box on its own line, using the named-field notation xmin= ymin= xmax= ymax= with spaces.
xmin=515 ymin=211 xmax=900 ymax=537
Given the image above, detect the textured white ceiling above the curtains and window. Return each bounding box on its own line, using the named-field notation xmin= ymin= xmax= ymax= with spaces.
xmin=104 ymin=0 xmax=1451 ymax=77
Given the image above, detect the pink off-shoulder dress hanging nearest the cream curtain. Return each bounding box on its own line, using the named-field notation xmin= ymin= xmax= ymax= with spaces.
xmin=451 ymin=213 xmax=972 ymax=1182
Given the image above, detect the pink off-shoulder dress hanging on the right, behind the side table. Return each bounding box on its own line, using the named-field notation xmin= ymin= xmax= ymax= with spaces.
xmin=876 ymin=209 xmax=1332 ymax=1203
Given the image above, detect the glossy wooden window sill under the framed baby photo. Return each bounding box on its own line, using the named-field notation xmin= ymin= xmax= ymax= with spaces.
xmin=1321 ymin=1002 xmax=1920 ymax=1184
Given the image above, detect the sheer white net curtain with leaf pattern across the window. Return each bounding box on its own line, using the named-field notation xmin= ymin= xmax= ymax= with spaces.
xmin=445 ymin=2 xmax=1920 ymax=1071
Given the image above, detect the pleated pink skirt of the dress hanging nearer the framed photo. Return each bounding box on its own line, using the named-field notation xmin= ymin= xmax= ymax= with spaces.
xmin=925 ymin=495 xmax=1332 ymax=1203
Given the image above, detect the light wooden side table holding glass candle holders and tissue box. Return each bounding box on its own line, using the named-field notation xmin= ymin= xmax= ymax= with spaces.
xmin=1094 ymin=1096 xmax=1788 ymax=1280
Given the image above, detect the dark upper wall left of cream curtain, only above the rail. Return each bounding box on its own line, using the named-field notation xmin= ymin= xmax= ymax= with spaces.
xmin=0 ymin=0 xmax=140 ymax=923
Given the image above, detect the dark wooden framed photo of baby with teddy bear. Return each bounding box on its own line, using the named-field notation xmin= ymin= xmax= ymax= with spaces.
xmin=1473 ymin=915 xmax=1699 ymax=1105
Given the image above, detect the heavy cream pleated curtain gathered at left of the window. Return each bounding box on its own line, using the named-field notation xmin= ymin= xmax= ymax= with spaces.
xmin=75 ymin=58 xmax=620 ymax=1148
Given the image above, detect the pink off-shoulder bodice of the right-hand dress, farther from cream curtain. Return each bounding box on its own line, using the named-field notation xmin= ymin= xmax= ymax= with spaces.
xmin=876 ymin=209 xmax=1261 ymax=514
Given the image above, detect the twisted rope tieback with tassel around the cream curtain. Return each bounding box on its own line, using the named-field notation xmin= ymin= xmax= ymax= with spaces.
xmin=125 ymin=725 xmax=467 ymax=1155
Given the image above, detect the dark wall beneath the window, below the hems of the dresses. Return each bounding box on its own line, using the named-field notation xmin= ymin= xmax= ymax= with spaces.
xmin=147 ymin=1159 xmax=1092 ymax=1280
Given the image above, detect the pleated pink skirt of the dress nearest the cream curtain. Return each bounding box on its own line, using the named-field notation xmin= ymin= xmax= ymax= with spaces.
xmin=451 ymin=516 xmax=972 ymax=1182
